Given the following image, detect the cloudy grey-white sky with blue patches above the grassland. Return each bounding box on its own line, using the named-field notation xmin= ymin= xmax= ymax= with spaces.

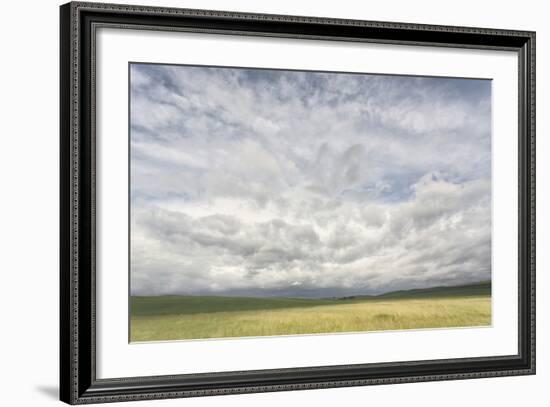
xmin=130 ymin=64 xmax=491 ymax=297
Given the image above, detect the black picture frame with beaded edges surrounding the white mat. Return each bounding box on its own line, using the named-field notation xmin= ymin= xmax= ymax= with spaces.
xmin=60 ymin=2 xmax=535 ymax=404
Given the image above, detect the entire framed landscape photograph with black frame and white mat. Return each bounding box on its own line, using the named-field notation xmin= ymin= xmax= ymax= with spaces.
xmin=60 ymin=2 xmax=535 ymax=404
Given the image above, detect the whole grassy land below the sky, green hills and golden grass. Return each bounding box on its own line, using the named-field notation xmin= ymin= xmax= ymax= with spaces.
xmin=130 ymin=282 xmax=491 ymax=342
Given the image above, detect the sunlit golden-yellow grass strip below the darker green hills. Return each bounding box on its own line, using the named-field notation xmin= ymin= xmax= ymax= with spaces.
xmin=131 ymin=296 xmax=491 ymax=342
